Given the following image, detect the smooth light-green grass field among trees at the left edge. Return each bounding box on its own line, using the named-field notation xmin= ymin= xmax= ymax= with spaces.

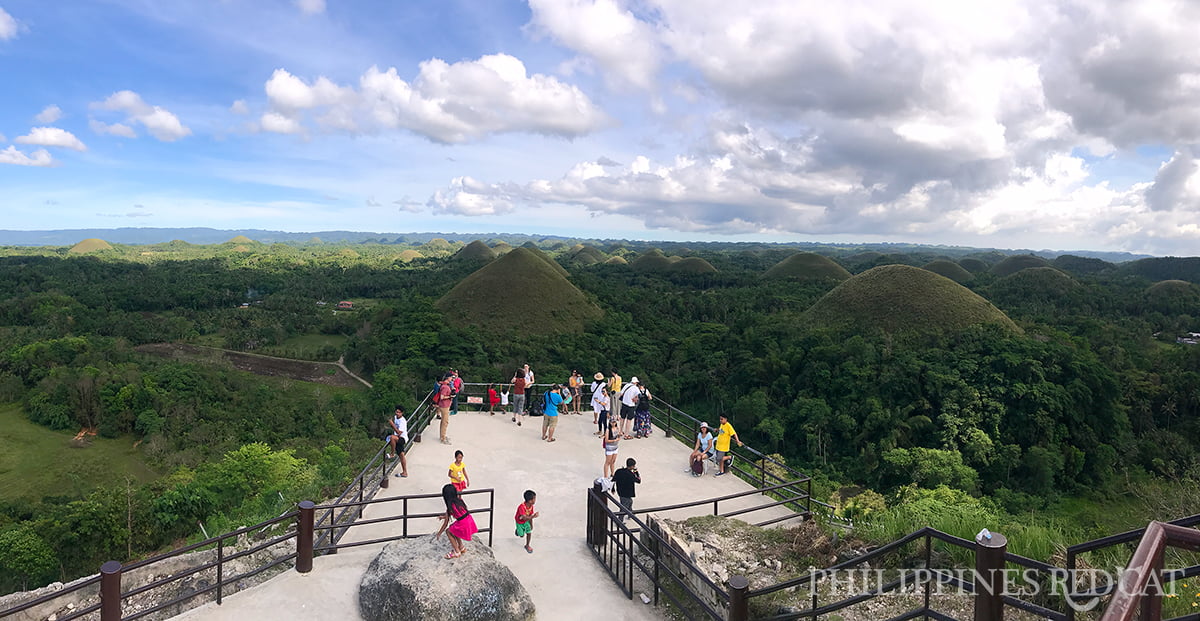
xmin=0 ymin=404 xmax=158 ymax=500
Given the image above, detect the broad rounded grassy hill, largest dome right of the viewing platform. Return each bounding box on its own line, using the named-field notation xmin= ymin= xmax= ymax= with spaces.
xmin=805 ymin=265 xmax=1019 ymax=334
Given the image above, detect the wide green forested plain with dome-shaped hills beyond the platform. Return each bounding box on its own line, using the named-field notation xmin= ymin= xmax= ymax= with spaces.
xmin=0 ymin=237 xmax=1200 ymax=592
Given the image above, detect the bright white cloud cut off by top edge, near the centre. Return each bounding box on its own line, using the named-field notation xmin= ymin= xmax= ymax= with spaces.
xmin=529 ymin=0 xmax=662 ymax=89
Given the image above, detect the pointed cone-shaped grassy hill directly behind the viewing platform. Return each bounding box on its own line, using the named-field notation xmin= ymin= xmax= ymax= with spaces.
xmin=436 ymin=248 xmax=604 ymax=334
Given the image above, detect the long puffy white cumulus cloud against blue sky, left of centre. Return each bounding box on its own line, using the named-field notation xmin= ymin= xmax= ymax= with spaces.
xmin=255 ymin=54 xmax=608 ymax=143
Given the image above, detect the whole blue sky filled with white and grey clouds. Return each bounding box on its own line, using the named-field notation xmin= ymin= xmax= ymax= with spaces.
xmin=0 ymin=0 xmax=1200 ymax=254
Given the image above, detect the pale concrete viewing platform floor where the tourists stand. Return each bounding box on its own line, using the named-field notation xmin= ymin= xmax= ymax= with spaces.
xmin=178 ymin=411 xmax=791 ymax=621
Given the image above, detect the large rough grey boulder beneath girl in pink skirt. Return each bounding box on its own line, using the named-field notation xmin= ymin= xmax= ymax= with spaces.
xmin=359 ymin=537 xmax=534 ymax=621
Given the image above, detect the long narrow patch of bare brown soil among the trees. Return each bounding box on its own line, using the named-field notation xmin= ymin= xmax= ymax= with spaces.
xmin=134 ymin=343 xmax=362 ymax=388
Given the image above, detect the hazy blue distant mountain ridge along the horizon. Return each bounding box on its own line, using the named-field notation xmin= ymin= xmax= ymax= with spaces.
xmin=0 ymin=227 xmax=1153 ymax=263
